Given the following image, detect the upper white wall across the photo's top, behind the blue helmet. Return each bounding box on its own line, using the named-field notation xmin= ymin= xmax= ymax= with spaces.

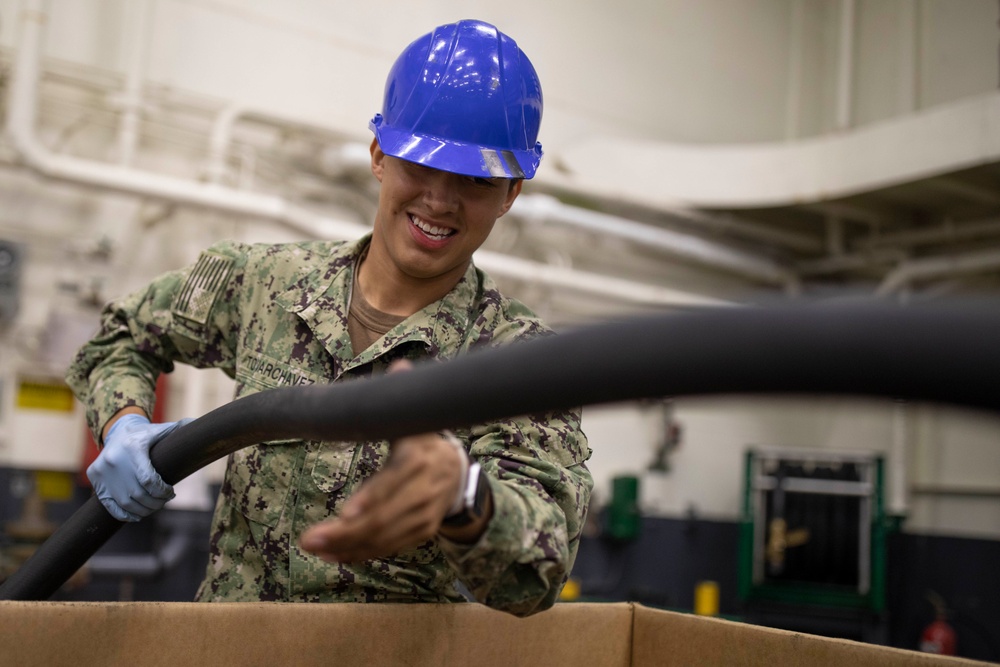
xmin=0 ymin=0 xmax=998 ymax=151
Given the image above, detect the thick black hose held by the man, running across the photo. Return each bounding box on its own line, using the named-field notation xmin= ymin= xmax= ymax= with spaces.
xmin=0 ymin=300 xmax=1000 ymax=600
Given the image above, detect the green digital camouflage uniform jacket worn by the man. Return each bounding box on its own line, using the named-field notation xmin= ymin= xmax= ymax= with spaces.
xmin=67 ymin=238 xmax=592 ymax=615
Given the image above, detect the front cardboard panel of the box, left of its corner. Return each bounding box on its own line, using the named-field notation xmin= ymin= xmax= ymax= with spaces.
xmin=0 ymin=602 xmax=632 ymax=667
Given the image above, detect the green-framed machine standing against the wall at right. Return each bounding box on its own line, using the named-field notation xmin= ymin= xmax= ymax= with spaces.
xmin=738 ymin=448 xmax=888 ymax=642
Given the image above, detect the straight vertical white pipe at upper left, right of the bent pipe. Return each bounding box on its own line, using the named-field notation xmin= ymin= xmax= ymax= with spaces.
xmin=118 ymin=0 xmax=150 ymax=167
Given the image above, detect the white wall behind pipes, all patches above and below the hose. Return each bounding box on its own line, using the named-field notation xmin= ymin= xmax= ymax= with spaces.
xmin=0 ymin=0 xmax=1000 ymax=536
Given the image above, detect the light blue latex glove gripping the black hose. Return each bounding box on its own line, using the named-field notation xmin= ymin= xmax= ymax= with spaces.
xmin=87 ymin=414 xmax=193 ymax=521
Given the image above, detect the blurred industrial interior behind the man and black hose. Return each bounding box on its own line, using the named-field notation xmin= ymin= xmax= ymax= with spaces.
xmin=0 ymin=0 xmax=1000 ymax=661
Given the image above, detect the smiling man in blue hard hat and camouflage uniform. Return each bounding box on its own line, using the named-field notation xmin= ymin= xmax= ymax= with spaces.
xmin=67 ymin=21 xmax=592 ymax=615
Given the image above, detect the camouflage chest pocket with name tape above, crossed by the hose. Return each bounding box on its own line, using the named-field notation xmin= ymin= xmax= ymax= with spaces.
xmin=223 ymin=357 xmax=318 ymax=528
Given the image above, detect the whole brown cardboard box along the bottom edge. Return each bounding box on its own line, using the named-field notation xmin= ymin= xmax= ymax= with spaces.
xmin=0 ymin=602 xmax=986 ymax=667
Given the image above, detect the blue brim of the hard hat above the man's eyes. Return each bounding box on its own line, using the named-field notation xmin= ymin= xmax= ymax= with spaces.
xmin=369 ymin=114 xmax=542 ymax=179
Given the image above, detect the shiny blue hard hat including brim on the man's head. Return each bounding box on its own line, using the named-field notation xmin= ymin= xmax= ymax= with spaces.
xmin=369 ymin=20 xmax=542 ymax=178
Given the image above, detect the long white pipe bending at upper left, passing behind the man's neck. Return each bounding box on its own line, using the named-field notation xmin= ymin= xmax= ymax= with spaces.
xmin=5 ymin=0 xmax=720 ymax=306
